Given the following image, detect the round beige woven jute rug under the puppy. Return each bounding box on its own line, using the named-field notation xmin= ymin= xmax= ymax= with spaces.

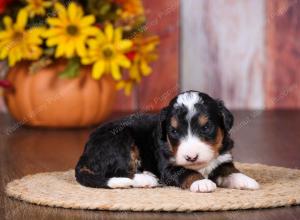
xmin=6 ymin=163 xmax=300 ymax=212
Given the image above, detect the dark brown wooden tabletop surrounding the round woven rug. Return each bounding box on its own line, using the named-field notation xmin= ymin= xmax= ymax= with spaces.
xmin=0 ymin=111 xmax=300 ymax=220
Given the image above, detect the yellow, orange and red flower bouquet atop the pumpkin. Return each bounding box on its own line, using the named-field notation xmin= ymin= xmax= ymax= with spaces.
xmin=0 ymin=0 xmax=159 ymax=94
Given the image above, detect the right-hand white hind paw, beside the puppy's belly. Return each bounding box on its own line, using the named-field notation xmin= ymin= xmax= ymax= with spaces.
xmin=133 ymin=171 xmax=158 ymax=188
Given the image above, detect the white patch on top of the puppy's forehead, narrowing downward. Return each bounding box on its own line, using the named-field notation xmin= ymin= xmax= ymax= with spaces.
xmin=174 ymin=92 xmax=203 ymax=119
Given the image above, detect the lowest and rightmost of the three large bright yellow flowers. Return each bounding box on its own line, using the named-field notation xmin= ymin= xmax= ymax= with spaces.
xmin=82 ymin=24 xmax=132 ymax=80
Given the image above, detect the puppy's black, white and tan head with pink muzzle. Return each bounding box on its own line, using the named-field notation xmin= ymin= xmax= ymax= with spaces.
xmin=161 ymin=91 xmax=233 ymax=170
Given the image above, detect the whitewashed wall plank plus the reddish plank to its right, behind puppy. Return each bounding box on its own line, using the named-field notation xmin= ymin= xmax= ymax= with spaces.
xmin=181 ymin=0 xmax=300 ymax=109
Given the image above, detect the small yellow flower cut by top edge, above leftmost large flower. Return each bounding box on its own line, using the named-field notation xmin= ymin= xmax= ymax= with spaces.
xmin=24 ymin=0 xmax=52 ymax=17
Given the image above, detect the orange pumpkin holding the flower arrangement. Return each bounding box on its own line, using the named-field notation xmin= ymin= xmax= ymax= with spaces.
xmin=4 ymin=61 xmax=116 ymax=127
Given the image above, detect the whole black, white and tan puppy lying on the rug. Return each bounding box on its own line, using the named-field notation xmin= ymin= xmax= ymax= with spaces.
xmin=75 ymin=91 xmax=259 ymax=192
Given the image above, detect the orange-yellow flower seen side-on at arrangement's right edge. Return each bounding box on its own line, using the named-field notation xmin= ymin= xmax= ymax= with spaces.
xmin=129 ymin=36 xmax=159 ymax=82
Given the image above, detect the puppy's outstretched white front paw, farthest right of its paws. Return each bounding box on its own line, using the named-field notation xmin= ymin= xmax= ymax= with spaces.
xmin=217 ymin=173 xmax=259 ymax=190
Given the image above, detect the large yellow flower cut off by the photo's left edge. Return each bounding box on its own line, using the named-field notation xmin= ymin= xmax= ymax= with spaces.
xmin=0 ymin=10 xmax=44 ymax=66
